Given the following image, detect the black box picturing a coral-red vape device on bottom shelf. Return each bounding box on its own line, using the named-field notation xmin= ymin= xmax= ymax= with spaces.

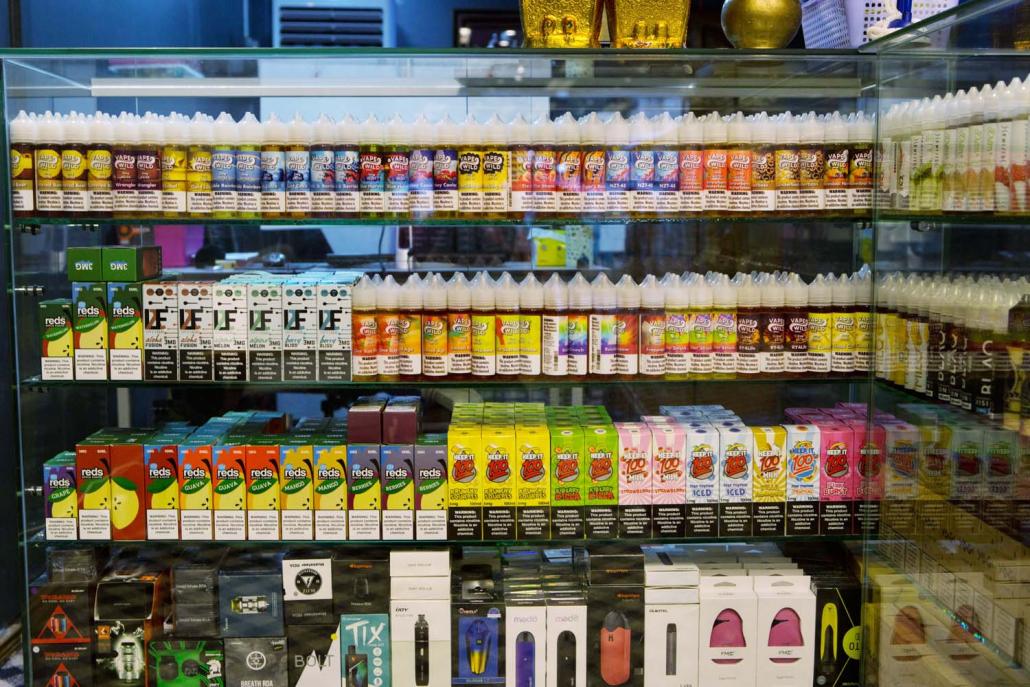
xmin=586 ymin=582 xmax=645 ymax=687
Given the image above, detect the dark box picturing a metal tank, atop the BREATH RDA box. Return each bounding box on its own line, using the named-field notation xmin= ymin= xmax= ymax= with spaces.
xmin=218 ymin=571 xmax=283 ymax=637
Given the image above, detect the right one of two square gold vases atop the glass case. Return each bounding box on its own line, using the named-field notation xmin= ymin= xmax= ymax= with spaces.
xmin=606 ymin=0 xmax=690 ymax=47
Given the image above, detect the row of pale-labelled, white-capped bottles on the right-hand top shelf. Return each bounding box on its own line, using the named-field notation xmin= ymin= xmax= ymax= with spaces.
xmin=878 ymin=77 xmax=1030 ymax=214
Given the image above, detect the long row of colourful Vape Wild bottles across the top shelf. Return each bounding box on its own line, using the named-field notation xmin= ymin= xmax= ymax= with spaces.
xmin=10 ymin=111 xmax=873 ymax=219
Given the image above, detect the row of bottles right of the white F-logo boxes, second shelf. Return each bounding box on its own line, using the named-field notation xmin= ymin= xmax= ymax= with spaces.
xmin=351 ymin=269 xmax=872 ymax=381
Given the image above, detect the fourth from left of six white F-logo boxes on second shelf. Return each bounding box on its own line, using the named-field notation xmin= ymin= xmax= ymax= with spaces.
xmin=244 ymin=278 xmax=282 ymax=382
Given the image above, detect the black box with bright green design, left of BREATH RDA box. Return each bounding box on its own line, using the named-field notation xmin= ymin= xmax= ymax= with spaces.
xmin=146 ymin=639 xmax=226 ymax=687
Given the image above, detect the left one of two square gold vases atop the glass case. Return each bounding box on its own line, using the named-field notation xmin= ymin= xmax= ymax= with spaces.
xmin=519 ymin=0 xmax=604 ymax=47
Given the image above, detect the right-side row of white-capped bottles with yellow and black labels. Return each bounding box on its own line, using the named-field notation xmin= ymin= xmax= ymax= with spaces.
xmin=876 ymin=274 xmax=1030 ymax=435
